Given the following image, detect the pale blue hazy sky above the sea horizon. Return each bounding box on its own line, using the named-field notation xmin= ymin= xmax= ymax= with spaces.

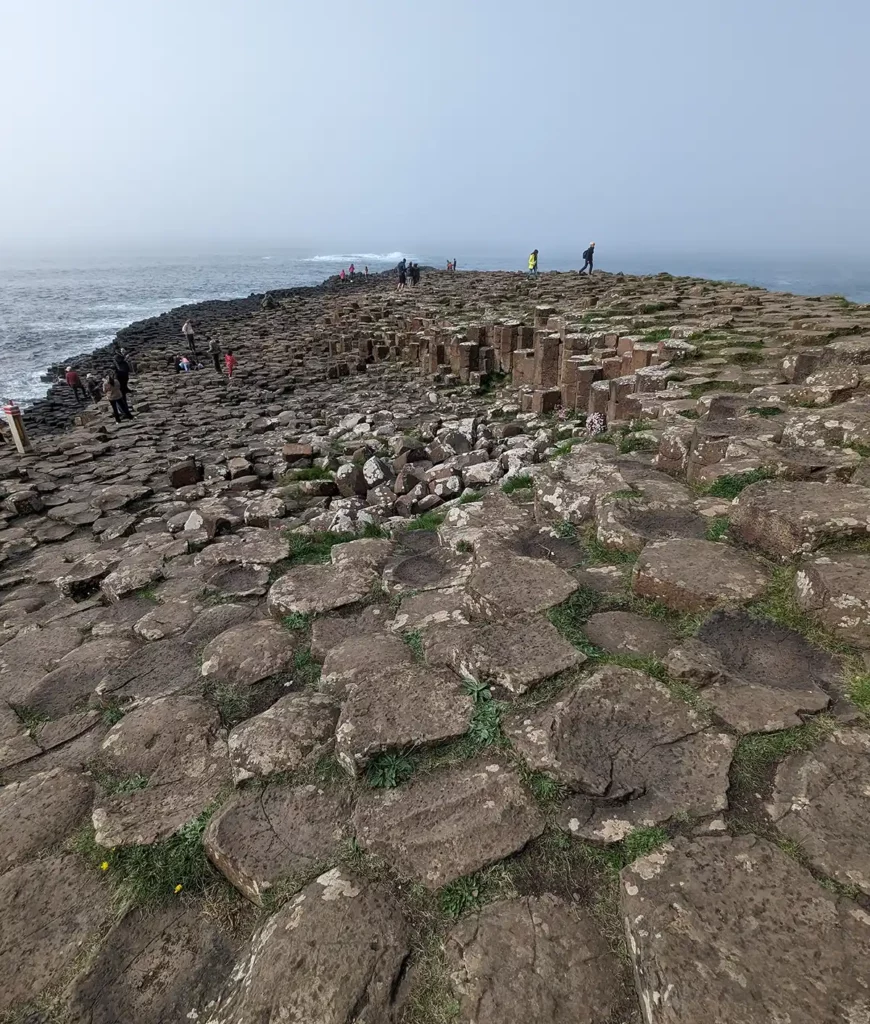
xmin=0 ymin=0 xmax=870 ymax=255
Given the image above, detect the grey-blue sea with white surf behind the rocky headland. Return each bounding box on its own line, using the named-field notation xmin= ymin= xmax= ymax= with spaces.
xmin=0 ymin=244 xmax=870 ymax=402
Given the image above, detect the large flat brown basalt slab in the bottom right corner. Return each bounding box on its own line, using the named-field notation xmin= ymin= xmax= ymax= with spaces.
xmin=621 ymin=836 xmax=870 ymax=1024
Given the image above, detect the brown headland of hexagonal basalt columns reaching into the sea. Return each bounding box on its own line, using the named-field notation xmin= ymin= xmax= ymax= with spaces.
xmin=0 ymin=271 xmax=870 ymax=1024
